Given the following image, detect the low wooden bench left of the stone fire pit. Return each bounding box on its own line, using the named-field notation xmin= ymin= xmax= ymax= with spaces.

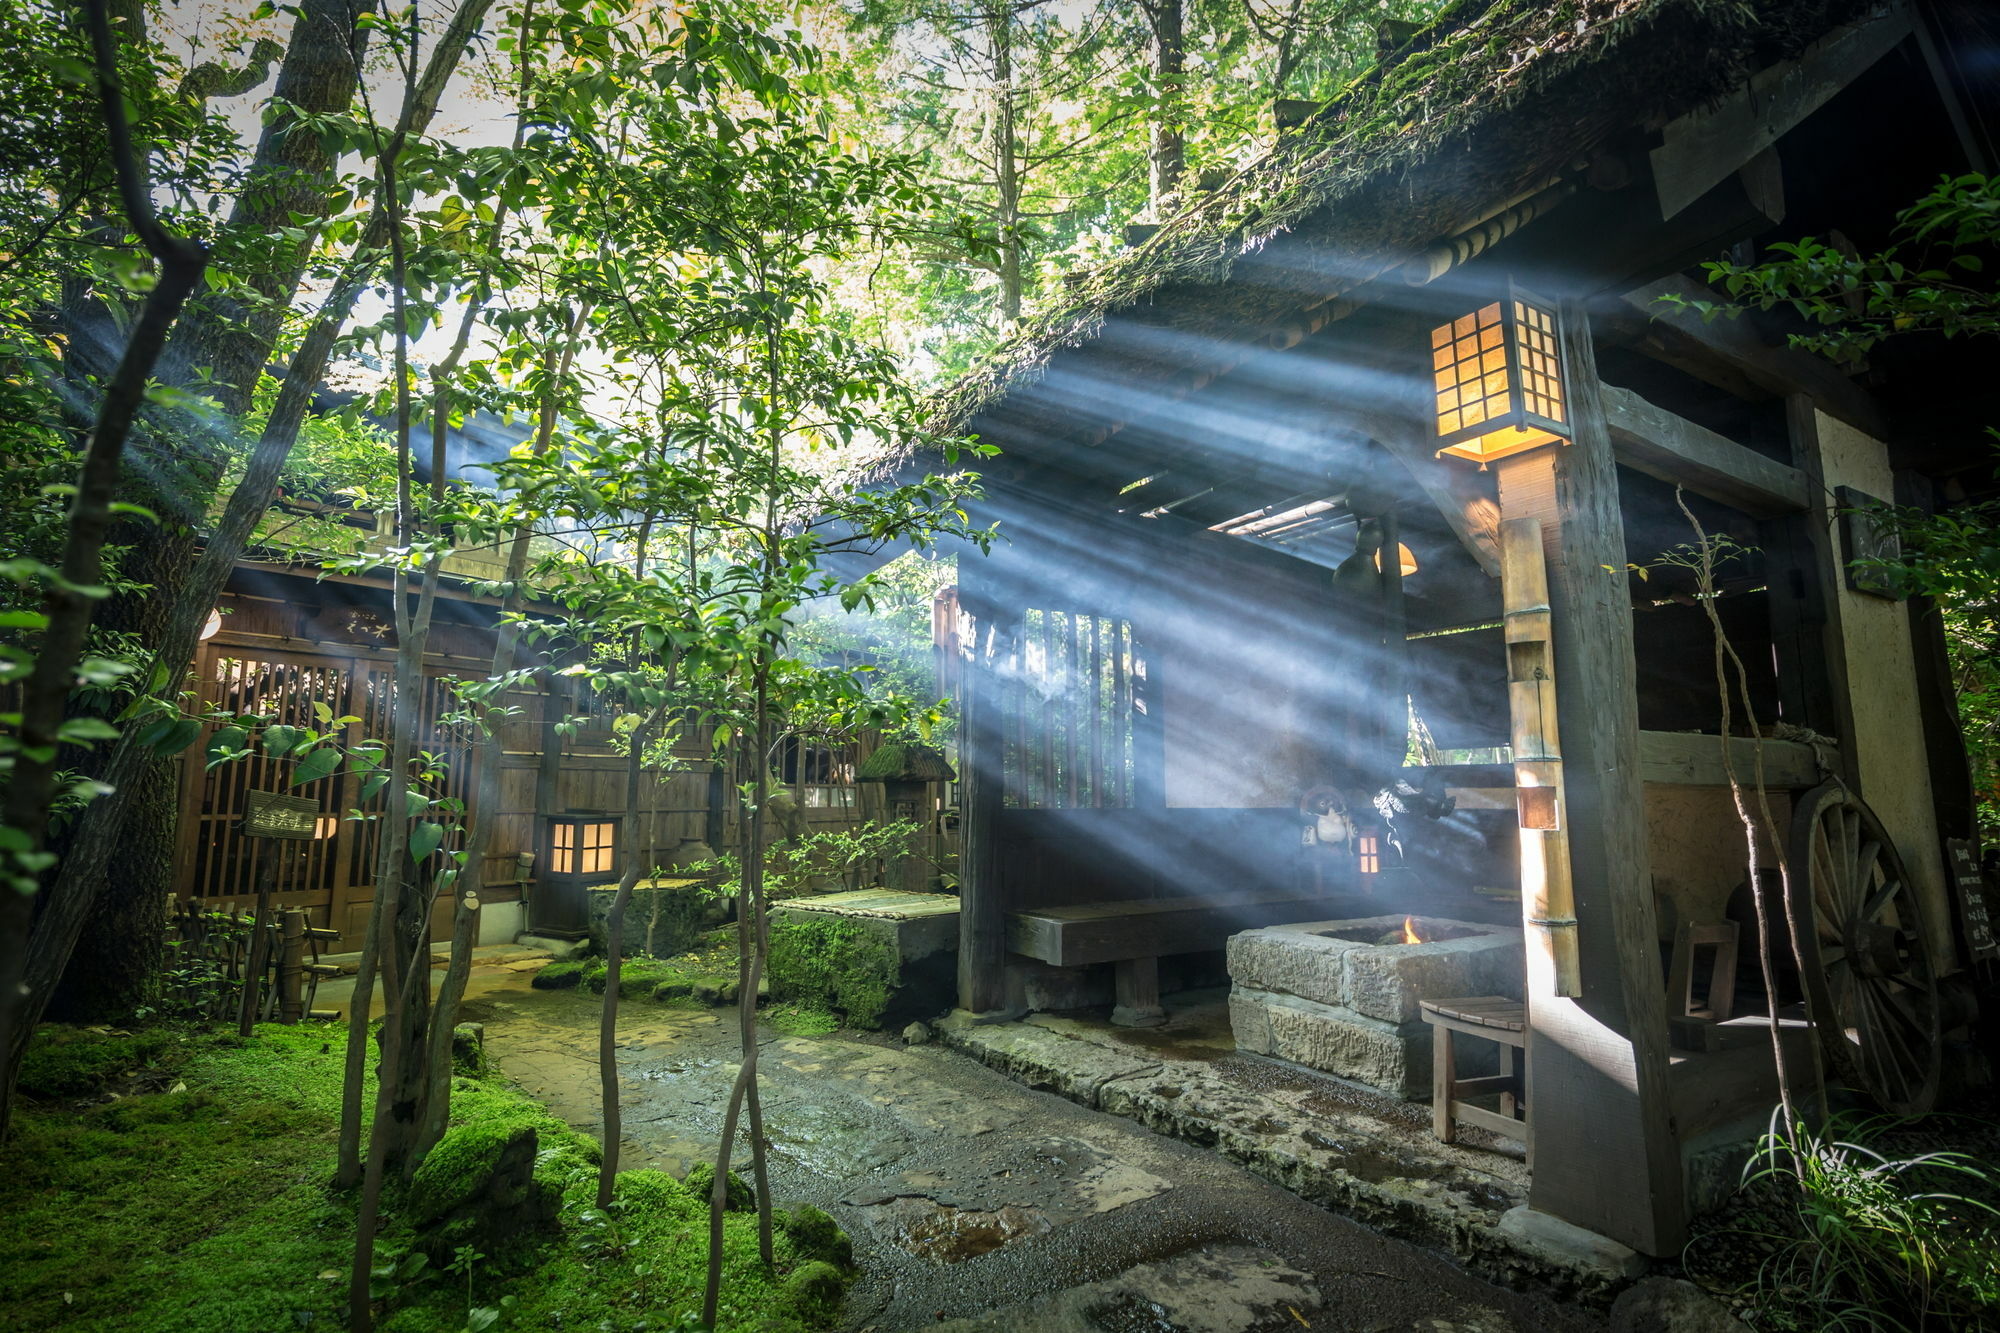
xmin=1006 ymin=889 xmax=1336 ymax=1027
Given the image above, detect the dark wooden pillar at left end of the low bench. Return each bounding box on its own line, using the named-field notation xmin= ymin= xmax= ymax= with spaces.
xmin=958 ymin=570 xmax=1020 ymax=1017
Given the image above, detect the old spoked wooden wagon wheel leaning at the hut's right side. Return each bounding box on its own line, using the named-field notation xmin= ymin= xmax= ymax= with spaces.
xmin=1790 ymin=779 xmax=1940 ymax=1115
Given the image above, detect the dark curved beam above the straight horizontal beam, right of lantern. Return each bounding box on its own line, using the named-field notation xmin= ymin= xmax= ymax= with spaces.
xmin=1602 ymin=278 xmax=1890 ymax=440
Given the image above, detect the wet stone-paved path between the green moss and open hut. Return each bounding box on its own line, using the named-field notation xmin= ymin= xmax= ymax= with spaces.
xmin=442 ymin=965 xmax=1604 ymax=1333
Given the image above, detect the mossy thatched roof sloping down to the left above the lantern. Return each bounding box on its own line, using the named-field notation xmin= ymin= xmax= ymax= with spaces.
xmin=928 ymin=0 xmax=1878 ymax=446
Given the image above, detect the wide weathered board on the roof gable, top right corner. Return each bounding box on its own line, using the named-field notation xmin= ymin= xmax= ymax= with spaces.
xmin=1652 ymin=6 xmax=1910 ymax=220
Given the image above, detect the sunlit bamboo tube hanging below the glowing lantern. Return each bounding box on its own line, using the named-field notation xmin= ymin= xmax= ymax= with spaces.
xmin=1500 ymin=518 xmax=1584 ymax=999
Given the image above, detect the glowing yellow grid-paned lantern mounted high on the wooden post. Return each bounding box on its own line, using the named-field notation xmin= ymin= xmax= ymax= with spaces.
xmin=1430 ymin=288 xmax=1570 ymax=470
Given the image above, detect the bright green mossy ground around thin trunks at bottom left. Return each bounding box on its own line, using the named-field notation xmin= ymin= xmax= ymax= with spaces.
xmin=0 ymin=1027 xmax=846 ymax=1333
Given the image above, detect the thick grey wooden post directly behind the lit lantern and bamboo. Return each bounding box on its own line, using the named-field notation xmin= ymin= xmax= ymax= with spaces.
xmin=1498 ymin=302 xmax=1686 ymax=1255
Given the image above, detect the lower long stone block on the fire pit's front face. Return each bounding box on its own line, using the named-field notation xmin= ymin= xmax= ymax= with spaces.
xmin=1230 ymin=987 xmax=1430 ymax=1099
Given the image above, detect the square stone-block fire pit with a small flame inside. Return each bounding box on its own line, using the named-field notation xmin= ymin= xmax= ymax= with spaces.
xmin=1228 ymin=915 xmax=1524 ymax=1101
